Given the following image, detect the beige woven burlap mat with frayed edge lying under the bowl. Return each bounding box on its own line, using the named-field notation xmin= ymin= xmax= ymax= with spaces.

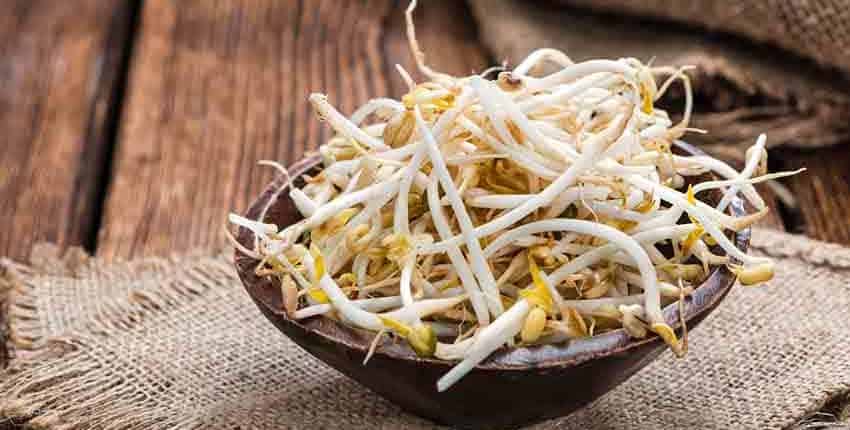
xmin=0 ymin=230 xmax=850 ymax=429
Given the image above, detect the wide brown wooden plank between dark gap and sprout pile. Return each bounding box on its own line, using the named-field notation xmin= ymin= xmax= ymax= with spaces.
xmin=98 ymin=0 xmax=485 ymax=257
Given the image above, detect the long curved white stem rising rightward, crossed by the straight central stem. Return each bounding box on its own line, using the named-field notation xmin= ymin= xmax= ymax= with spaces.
xmin=422 ymin=115 xmax=626 ymax=253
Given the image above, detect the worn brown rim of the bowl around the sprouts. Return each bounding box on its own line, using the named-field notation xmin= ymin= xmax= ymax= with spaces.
xmin=234 ymin=142 xmax=751 ymax=371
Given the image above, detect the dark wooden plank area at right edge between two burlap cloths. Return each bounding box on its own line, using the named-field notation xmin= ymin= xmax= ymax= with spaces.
xmin=779 ymin=145 xmax=850 ymax=244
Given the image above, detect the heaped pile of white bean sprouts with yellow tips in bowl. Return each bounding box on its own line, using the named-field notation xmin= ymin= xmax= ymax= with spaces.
xmin=225 ymin=5 xmax=797 ymax=391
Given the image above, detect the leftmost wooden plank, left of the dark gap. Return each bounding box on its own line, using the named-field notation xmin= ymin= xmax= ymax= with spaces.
xmin=0 ymin=0 xmax=130 ymax=259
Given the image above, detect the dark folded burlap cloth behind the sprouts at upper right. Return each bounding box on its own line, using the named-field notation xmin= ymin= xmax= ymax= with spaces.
xmin=468 ymin=0 xmax=850 ymax=158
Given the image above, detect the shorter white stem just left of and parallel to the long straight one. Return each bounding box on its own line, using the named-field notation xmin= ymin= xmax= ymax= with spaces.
xmin=428 ymin=172 xmax=490 ymax=326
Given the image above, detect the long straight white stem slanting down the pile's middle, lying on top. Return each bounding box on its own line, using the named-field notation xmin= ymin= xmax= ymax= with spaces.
xmin=414 ymin=106 xmax=504 ymax=316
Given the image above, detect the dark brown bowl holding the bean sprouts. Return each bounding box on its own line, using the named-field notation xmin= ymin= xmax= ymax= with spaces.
xmin=235 ymin=146 xmax=750 ymax=428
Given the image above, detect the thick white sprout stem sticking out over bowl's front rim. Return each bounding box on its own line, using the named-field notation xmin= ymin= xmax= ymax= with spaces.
xmin=437 ymin=299 xmax=531 ymax=392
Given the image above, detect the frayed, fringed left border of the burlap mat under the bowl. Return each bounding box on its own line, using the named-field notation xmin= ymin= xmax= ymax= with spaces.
xmin=0 ymin=250 xmax=233 ymax=429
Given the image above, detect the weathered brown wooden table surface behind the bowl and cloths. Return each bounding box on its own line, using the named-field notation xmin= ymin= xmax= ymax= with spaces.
xmin=0 ymin=0 xmax=850 ymax=422
